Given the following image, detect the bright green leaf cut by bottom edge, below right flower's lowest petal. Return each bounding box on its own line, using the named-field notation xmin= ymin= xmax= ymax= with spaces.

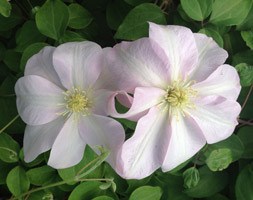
xmin=129 ymin=186 xmax=162 ymax=200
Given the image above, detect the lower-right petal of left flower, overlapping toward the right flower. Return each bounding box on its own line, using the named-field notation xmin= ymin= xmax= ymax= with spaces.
xmin=79 ymin=115 xmax=125 ymax=168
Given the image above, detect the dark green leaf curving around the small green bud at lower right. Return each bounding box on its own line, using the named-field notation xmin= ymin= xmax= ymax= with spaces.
xmin=184 ymin=166 xmax=228 ymax=198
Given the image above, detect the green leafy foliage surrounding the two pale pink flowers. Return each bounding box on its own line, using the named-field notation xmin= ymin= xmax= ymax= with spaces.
xmin=0 ymin=0 xmax=253 ymax=200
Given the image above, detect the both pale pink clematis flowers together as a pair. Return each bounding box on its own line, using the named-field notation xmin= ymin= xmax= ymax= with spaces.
xmin=15 ymin=23 xmax=241 ymax=179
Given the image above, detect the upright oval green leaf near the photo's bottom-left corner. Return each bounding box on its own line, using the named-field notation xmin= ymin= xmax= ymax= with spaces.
xmin=6 ymin=166 xmax=30 ymax=196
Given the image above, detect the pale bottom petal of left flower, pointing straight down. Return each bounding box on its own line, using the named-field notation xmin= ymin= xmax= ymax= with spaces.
xmin=48 ymin=115 xmax=86 ymax=169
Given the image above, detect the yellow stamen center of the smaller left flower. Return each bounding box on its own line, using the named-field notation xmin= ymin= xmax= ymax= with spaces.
xmin=64 ymin=88 xmax=91 ymax=115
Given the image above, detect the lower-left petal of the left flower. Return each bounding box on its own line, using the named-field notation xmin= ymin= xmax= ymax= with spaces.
xmin=24 ymin=117 xmax=65 ymax=162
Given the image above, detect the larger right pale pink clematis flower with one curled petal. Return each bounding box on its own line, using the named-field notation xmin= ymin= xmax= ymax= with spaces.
xmin=107 ymin=23 xmax=241 ymax=179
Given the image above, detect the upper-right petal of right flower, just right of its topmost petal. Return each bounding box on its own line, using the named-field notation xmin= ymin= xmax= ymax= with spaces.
xmin=189 ymin=33 xmax=228 ymax=82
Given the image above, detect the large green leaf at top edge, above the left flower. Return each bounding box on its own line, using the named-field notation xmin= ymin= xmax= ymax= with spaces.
xmin=35 ymin=0 xmax=69 ymax=40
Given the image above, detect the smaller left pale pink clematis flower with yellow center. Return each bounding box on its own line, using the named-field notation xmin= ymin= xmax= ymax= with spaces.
xmin=15 ymin=42 xmax=124 ymax=168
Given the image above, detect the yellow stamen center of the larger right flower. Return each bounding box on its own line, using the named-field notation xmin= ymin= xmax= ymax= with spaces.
xmin=165 ymin=81 xmax=197 ymax=112
